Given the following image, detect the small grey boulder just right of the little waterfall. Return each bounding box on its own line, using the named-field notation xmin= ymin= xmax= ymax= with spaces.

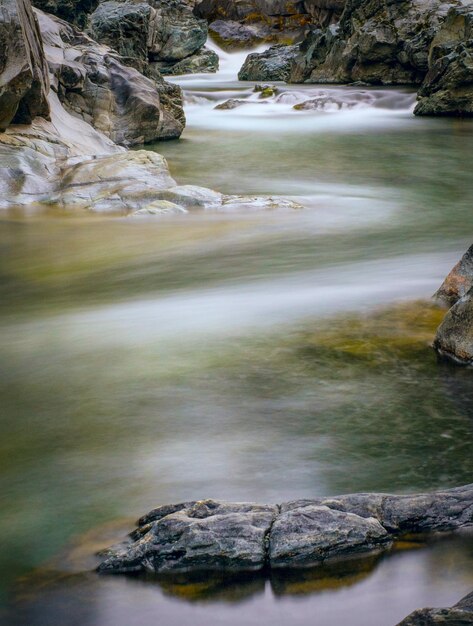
xmin=238 ymin=45 xmax=299 ymax=81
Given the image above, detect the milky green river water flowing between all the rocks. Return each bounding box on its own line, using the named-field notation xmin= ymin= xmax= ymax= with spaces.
xmin=0 ymin=41 xmax=473 ymax=626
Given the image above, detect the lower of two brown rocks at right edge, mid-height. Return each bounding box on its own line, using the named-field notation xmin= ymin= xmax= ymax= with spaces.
xmin=434 ymin=288 xmax=473 ymax=365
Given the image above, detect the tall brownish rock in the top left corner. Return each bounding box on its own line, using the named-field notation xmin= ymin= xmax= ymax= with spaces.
xmin=0 ymin=0 xmax=49 ymax=130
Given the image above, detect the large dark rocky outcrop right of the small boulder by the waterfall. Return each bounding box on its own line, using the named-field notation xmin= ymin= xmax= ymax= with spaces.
xmin=290 ymin=0 xmax=460 ymax=85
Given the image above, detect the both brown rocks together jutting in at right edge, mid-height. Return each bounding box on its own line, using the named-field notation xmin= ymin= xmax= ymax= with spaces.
xmin=434 ymin=246 xmax=473 ymax=365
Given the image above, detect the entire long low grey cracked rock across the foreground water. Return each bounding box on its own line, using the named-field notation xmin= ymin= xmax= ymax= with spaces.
xmin=99 ymin=485 xmax=473 ymax=573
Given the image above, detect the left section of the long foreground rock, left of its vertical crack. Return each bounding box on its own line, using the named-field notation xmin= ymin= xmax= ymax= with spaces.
xmin=99 ymin=500 xmax=277 ymax=572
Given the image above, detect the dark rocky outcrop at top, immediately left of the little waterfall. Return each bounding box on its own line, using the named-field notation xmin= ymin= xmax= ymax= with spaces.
xmin=90 ymin=0 xmax=212 ymax=74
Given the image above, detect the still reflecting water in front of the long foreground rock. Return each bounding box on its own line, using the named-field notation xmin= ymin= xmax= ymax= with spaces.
xmin=5 ymin=535 xmax=473 ymax=626
